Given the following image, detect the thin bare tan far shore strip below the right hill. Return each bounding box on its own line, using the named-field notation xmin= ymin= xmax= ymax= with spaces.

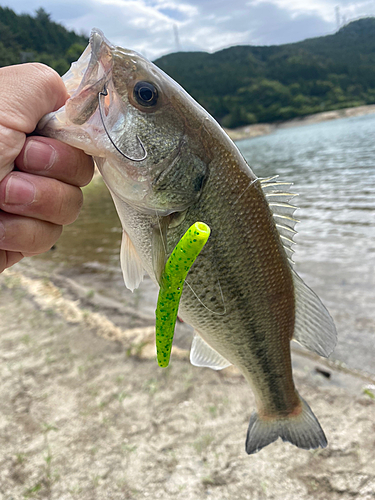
xmin=224 ymin=104 xmax=375 ymax=141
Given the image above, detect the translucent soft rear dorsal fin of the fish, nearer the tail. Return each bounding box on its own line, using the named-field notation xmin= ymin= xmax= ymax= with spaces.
xmin=292 ymin=271 xmax=337 ymax=358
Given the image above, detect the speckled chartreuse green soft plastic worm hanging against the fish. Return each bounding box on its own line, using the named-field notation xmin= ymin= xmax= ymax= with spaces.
xmin=155 ymin=222 xmax=211 ymax=368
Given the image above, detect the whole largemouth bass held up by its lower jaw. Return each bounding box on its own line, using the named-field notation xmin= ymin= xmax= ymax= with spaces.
xmin=37 ymin=29 xmax=337 ymax=454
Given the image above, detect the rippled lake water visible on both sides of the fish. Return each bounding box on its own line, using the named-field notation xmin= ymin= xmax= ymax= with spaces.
xmin=33 ymin=114 xmax=375 ymax=373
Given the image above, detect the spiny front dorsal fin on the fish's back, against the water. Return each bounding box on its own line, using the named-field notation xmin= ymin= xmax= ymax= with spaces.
xmin=259 ymin=175 xmax=298 ymax=265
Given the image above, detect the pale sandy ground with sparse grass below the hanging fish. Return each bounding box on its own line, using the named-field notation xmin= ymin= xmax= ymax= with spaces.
xmin=0 ymin=261 xmax=375 ymax=500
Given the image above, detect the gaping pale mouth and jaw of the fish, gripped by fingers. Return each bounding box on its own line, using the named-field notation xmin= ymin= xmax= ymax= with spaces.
xmin=37 ymin=28 xmax=155 ymax=162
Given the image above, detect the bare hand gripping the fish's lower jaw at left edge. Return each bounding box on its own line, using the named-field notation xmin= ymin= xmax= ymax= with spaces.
xmin=0 ymin=63 xmax=94 ymax=272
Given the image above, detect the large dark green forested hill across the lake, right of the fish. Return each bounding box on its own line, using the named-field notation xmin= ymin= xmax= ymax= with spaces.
xmin=155 ymin=18 xmax=375 ymax=127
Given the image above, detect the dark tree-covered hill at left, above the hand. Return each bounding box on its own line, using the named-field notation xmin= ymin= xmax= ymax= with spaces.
xmin=0 ymin=7 xmax=88 ymax=74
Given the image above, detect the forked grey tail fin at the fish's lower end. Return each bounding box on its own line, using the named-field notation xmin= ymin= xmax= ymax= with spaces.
xmin=246 ymin=397 xmax=327 ymax=455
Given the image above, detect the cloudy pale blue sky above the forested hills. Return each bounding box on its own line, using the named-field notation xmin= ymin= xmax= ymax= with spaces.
xmin=0 ymin=0 xmax=375 ymax=59
